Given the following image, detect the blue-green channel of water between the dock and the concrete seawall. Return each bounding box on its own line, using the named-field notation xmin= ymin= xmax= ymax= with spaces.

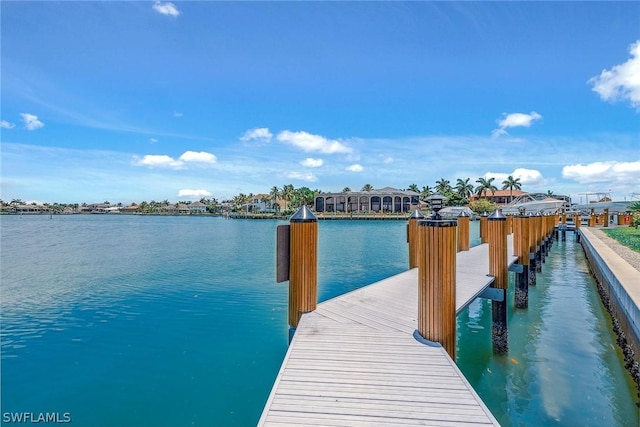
xmin=458 ymin=235 xmax=640 ymax=427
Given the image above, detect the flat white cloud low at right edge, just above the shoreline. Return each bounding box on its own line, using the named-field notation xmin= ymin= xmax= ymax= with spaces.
xmin=562 ymin=161 xmax=640 ymax=185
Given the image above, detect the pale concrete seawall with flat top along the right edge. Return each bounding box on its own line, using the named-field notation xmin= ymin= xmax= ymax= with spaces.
xmin=579 ymin=228 xmax=640 ymax=374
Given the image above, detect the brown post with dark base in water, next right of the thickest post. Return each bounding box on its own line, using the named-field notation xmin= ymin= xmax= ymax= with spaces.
xmin=487 ymin=210 xmax=509 ymax=354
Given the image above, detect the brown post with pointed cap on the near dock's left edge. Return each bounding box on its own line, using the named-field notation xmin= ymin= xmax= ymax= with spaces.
xmin=289 ymin=205 xmax=318 ymax=337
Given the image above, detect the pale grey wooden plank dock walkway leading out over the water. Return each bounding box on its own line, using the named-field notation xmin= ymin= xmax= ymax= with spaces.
xmin=258 ymin=235 xmax=517 ymax=426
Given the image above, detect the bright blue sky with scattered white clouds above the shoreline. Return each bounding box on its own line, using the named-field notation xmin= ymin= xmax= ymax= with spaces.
xmin=0 ymin=1 xmax=640 ymax=203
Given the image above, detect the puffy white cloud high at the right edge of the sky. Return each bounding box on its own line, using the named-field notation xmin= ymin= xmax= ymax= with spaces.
xmin=588 ymin=40 xmax=640 ymax=110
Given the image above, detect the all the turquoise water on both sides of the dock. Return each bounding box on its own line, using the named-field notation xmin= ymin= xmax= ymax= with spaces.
xmin=0 ymin=219 xmax=639 ymax=426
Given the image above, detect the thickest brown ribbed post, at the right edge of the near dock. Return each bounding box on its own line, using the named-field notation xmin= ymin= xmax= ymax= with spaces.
xmin=418 ymin=206 xmax=458 ymax=360
